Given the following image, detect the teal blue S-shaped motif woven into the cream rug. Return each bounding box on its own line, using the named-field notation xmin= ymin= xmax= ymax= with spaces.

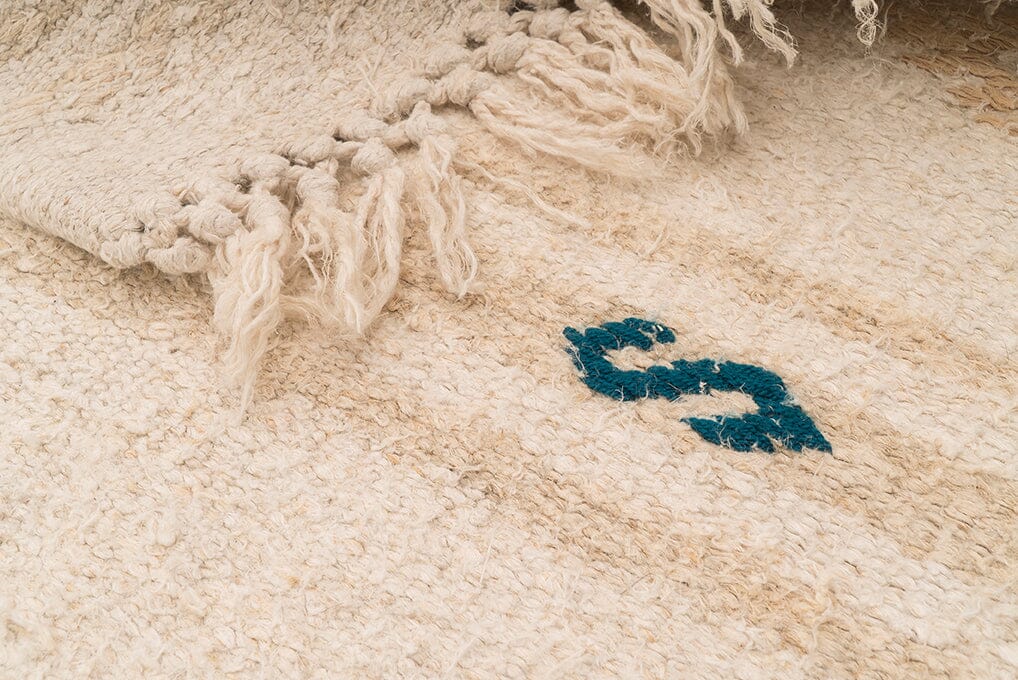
xmin=563 ymin=319 xmax=831 ymax=453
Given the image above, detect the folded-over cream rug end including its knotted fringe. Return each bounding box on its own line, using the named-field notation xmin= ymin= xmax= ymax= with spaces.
xmin=0 ymin=0 xmax=871 ymax=403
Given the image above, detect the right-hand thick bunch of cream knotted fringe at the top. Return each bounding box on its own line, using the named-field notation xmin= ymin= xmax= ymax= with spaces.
xmin=366 ymin=0 xmax=795 ymax=176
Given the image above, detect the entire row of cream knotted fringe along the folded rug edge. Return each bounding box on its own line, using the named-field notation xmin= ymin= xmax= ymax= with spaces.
xmin=145 ymin=0 xmax=875 ymax=404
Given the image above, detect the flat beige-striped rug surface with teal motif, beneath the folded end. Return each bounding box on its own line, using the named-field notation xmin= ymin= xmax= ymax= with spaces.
xmin=0 ymin=3 xmax=1018 ymax=678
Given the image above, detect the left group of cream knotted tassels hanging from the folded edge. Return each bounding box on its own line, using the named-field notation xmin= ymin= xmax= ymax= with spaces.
xmin=161 ymin=102 xmax=477 ymax=406
